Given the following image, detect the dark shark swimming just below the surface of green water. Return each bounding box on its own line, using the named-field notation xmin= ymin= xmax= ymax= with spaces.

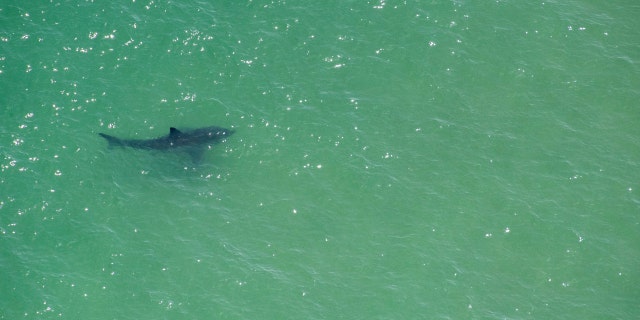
xmin=98 ymin=126 xmax=235 ymax=163
